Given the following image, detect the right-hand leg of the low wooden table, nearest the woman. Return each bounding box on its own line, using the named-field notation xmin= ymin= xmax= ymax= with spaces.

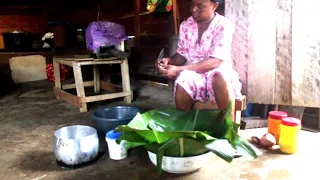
xmin=121 ymin=59 xmax=132 ymax=104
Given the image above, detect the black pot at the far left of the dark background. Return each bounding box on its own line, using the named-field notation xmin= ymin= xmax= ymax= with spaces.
xmin=2 ymin=31 xmax=31 ymax=49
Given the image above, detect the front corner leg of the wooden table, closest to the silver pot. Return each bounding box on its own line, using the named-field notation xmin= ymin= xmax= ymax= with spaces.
xmin=72 ymin=62 xmax=88 ymax=112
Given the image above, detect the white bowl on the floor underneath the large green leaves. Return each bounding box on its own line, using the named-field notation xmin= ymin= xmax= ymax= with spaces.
xmin=148 ymin=151 xmax=213 ymax=174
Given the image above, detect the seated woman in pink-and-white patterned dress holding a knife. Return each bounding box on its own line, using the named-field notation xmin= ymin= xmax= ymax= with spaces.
xmin=156 ymin=0 xmax=242 ymax=111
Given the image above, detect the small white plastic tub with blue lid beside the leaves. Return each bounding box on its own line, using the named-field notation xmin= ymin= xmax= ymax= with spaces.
xmin=106 ymin=130 xmax=128 ymax=160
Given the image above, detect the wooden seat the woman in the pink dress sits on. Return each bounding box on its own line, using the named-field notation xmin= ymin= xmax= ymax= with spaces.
xmin=193 ymin=96 xmax=247 ymax=124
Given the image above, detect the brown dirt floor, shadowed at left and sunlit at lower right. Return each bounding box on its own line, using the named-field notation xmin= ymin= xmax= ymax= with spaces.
xmin=0 ymin=82 xmax=320 ymax=180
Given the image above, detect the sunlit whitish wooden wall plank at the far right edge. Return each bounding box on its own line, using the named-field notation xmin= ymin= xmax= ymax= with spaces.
xmin=292 ymin=0 xmax=320 ymax=107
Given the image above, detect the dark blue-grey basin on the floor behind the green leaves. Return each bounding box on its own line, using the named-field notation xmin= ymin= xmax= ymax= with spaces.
xmin=92 ymin=106 xmax=141 ymax=134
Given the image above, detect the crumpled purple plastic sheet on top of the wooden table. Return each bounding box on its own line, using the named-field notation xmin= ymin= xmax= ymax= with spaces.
xmin=86 ymin=21 xmax=128 ymax=51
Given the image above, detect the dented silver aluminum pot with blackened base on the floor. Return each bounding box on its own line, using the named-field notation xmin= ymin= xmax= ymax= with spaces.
xmin=54 ymin=125 xmax=99 ymax=166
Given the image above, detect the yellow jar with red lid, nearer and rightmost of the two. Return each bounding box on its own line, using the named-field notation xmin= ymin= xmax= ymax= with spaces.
xmin=279 ymin=117 xmax=301 ymax=154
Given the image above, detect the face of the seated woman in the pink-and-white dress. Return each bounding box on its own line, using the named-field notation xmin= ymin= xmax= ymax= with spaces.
xmin=191 ymin=0 xmax=219 ymax=22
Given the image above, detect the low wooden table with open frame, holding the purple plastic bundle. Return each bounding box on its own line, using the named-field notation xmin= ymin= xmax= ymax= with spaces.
xmin=53 ymin=56 xmax=132 ymax=112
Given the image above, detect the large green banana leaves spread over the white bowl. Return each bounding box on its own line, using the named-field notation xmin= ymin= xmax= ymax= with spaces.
xmin=116 ymin=101 xmax=260 ymax=174
